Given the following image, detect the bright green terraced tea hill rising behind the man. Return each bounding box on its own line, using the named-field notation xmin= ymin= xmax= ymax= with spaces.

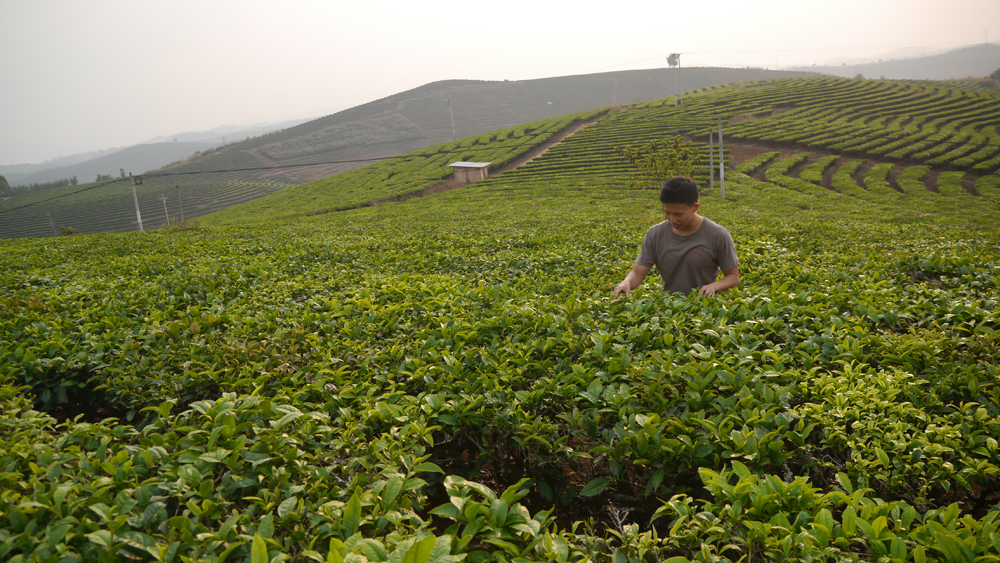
xmin=203 ymin=79 xmax=1000 ymax=224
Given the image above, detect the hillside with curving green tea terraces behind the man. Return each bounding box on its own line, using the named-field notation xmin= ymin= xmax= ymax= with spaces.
xmin=205 ymin=79 xmax=1000 ymax=228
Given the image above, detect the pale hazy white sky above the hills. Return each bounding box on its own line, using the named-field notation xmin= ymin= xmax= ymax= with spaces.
xmin=0 ymin=0 xmax=1000 ymax=164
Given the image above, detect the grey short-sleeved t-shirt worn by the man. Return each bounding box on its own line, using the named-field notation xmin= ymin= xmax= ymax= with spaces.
xmin=635 ymin=217 xmax=739 ymax=294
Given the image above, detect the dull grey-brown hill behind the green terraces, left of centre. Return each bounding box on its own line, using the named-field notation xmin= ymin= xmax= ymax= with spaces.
xmin=0 ymin=68 xmax=811 ymax=238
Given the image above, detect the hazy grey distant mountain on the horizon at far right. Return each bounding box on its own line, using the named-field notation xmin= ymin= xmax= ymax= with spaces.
xmin=787 ymin=43 xmax=1000 ymax=80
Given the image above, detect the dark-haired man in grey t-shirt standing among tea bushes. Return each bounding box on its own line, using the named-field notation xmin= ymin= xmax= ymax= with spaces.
xmin=614 ymin=176 xmax=740 ymax=298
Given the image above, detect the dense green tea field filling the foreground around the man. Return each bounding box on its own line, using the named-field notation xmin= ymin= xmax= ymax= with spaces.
xmin=0 ymin=80 xmax=1000 ymax=563
